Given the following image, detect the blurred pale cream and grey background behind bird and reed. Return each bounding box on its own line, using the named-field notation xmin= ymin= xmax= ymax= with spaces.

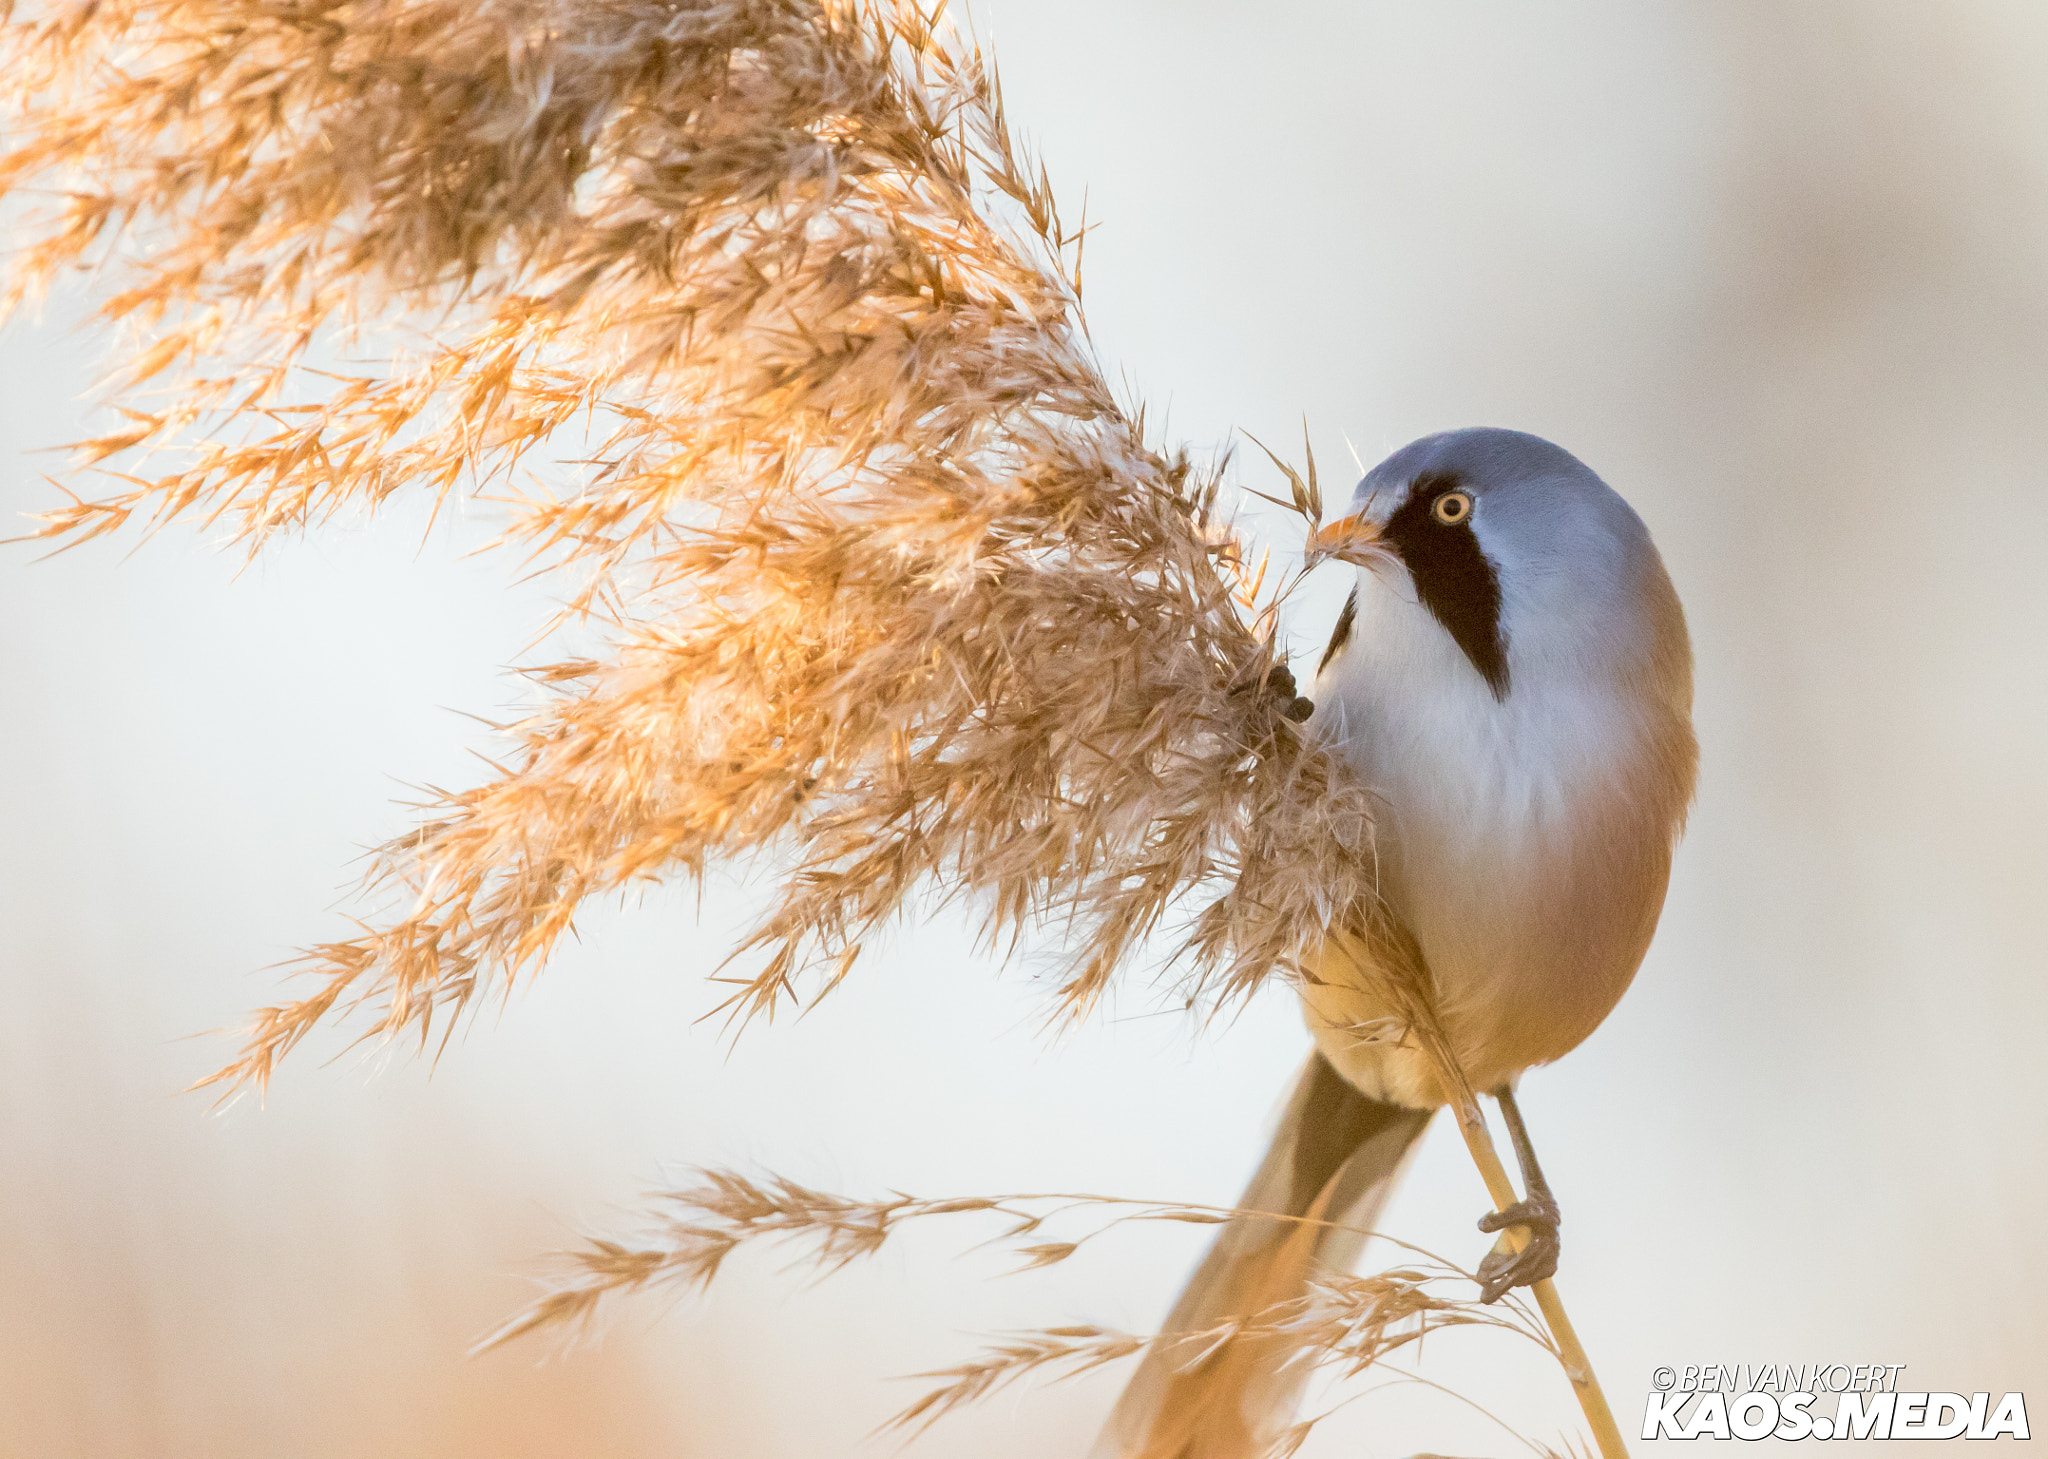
xmin=0 ymin=0 xmax=2048 ymax=1459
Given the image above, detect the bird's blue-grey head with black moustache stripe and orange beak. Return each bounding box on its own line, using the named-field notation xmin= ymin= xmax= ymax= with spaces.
xmin=1309 ymin=428 xmax=1692 ymax=701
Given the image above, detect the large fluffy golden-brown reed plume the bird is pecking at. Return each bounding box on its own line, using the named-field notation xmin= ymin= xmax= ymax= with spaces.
xmin=0 ymin=0 xmax=1372 ymax=1088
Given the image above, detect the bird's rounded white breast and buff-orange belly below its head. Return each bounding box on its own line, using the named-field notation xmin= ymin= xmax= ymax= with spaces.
xmin=1305 ymin=568 xmax=1690 ymax=1104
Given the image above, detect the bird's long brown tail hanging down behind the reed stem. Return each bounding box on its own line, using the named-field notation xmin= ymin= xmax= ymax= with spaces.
xmin=1092 ymin=1053 xmax=1430 ymax=1459
